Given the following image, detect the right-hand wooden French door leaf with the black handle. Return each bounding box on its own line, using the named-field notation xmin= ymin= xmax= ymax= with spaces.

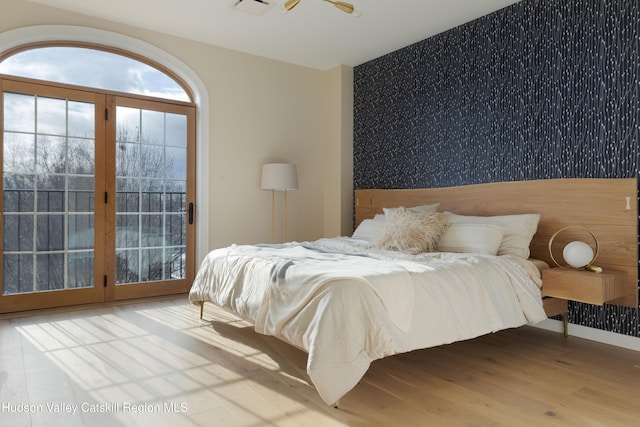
xmin=107 ymin=97 xmax=195 ymax=299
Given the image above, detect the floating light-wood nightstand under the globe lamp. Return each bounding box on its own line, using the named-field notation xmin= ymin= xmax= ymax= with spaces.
xmin=542 ymin=268 xmax=626 ymax=305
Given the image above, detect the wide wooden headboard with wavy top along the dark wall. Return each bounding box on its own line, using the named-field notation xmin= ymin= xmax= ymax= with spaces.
xmin=355 ymin=178 xmax=638 ymax=307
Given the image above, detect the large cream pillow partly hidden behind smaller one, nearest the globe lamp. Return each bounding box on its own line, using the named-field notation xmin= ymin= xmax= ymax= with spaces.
xmin=445 ymin=212 xmax=540 ymax=259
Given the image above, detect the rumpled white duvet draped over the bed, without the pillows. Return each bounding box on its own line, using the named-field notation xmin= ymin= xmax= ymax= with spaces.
xmin=189 ymin=237 xmax=546 ymax=404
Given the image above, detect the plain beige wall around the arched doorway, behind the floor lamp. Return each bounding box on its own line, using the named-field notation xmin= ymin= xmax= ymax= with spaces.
xmin=0 ymin=0 xmax=353 ymax=261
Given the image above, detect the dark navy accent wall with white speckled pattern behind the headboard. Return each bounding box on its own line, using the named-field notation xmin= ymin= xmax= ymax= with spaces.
xmin=354 ymin=0 xmax=640 ymax=336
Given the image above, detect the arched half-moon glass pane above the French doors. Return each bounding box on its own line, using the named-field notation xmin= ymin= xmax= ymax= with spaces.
xmin=0 ymin=47 xmax=190 ymax=102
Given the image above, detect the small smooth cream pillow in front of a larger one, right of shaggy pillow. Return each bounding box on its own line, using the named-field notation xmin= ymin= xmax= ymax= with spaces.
xmin=438 ymin=223 xmax=504 ymax=255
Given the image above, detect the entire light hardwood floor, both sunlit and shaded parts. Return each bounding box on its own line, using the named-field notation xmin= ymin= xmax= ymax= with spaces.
xmin=0 ymin=296 xmax=640 ymax=427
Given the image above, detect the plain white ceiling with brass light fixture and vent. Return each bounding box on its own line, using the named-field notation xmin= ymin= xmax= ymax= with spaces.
xmin=31 ymin=0 xmax=519 ymax=70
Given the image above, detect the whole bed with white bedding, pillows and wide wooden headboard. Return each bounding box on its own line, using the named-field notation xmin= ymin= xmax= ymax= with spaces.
xmin=189 ymin=179 xmax=638 ymax=404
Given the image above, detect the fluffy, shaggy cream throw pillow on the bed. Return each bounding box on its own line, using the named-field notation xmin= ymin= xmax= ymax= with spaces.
xmin=372 ymin=208 xmax=446 ymax=255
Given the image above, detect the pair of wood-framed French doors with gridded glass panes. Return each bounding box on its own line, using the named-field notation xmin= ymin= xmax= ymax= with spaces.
xmin=0 ymin=80 xmax=195 ymax=312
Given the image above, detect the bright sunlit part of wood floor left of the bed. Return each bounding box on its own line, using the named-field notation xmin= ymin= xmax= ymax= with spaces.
xmin=0 ymin=300 xmax=350 ymax=427
